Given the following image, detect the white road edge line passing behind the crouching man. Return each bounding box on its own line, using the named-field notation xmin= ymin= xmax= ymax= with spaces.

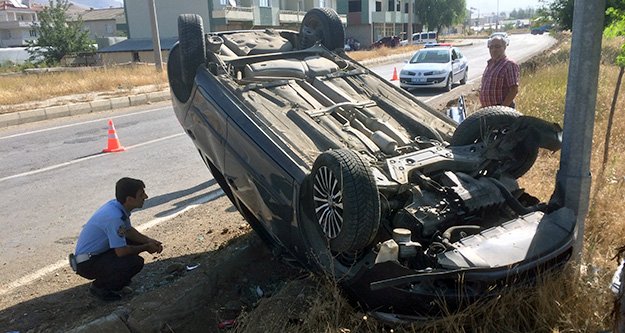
xmin=0 ymin=189 xmax=225 ymax=296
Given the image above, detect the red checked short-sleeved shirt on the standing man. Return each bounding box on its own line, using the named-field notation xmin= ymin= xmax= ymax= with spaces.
xmin=480 ymin=56 xmax=521 ymax=107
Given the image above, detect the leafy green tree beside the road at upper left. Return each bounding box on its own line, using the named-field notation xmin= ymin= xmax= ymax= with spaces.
xmin=28 ymin=0 xmax=94 ymax=64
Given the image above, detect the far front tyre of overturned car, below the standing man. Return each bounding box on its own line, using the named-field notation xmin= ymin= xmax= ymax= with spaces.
xmin=450 ymin=105 xmax=538 ymax=178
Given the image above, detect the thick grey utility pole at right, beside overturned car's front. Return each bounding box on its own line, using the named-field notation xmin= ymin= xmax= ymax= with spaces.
xmin=554 ymin=0 xmax=605 ymax=260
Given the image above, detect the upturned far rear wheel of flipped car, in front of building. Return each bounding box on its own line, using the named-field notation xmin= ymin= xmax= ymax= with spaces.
xmin=299 ymin=7 xmax=345 ymax=50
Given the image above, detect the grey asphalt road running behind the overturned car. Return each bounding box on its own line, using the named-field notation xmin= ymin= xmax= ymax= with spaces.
xmin=0 ymin=34 xmax=554 ymax=290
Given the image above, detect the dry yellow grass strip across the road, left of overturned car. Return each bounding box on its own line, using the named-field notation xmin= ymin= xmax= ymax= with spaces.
xmin=0 ymin=65 xmax=167 ymax=106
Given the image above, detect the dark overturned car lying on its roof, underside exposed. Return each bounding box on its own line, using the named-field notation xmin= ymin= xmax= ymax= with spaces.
xmin=167 ymin=8 xmax=575 ymax=322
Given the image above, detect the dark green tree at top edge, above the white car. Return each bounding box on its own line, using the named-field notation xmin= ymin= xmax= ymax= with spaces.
xmin=414 ymin=0 xmax=467 ymax=32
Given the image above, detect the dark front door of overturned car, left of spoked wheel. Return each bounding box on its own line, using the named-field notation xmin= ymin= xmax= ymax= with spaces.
xmin=224 ymin=107 xmax=304 ymax=243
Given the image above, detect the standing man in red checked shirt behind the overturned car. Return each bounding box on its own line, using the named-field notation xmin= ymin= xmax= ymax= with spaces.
xmin=480 ymin=36 xmax=521 ymax=108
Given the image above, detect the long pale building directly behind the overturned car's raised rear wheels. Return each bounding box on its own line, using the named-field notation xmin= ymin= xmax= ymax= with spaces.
xmin=99 ymin=0 xmax=347 ymax=63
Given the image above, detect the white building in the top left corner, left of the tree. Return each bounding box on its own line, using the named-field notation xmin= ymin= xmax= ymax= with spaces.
xmin=0 ymin=0 xmax=38 ymax=47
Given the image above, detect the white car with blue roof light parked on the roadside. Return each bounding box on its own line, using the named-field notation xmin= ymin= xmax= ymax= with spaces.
xmin=399 ymin=46 xmax=469 ymax=91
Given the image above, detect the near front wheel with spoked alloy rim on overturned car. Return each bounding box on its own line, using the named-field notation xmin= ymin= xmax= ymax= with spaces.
xmin=309 ymin=149 xmax=380 ymax=252
